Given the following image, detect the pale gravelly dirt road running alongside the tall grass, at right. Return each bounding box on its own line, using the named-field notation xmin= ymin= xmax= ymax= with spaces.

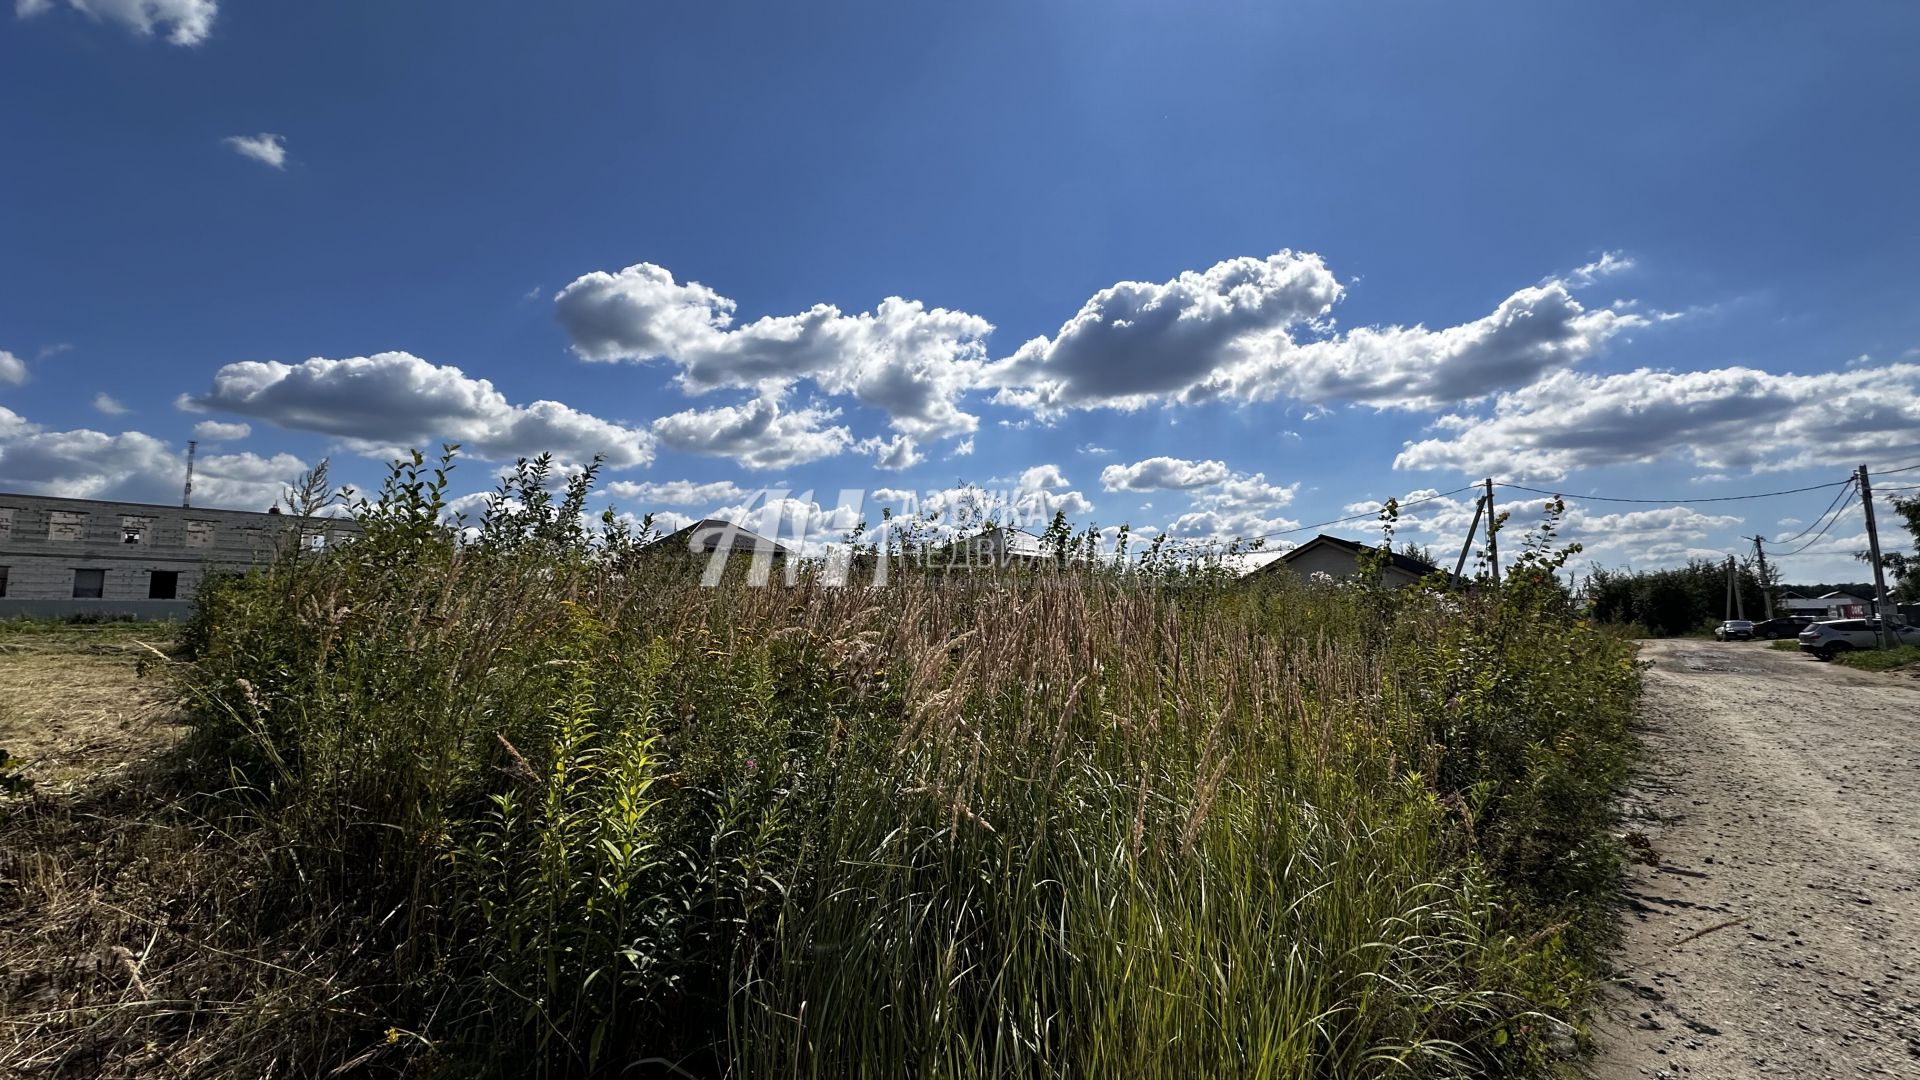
xmin=1596 ymin=640 xmax=1920 ymax=1080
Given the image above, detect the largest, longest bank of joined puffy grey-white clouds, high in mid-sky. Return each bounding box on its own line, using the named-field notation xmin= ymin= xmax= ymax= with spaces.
xmin=555 ymin=250 xmax=1649 ymax=443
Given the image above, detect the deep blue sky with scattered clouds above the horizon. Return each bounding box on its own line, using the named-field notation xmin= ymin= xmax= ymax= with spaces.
xmin=0 ymin=0 xmax=1920 ymax=578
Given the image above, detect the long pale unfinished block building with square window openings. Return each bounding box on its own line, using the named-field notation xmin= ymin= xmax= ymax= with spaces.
xmin=0 ymin=492 xmax=353 ymax=619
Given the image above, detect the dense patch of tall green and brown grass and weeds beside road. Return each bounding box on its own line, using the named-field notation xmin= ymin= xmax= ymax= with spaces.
xmin=165 ymin=449 xmax=1636 ymax=1078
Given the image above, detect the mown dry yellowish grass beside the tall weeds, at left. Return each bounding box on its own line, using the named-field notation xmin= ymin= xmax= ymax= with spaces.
xmin=0 ymin=623 xmax=355 ymax=1078
